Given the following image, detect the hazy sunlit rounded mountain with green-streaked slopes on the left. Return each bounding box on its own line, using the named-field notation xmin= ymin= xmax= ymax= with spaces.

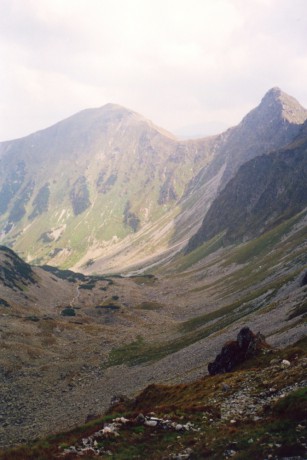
xmin=0 ymin=104 xmax=219 ymax=266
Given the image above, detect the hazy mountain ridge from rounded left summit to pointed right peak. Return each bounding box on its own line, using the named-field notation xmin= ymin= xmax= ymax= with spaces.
xmin=0 ymin=88 xmax=307 ymax=272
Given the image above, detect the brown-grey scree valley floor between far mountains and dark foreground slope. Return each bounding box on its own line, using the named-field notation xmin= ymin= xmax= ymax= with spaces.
xmin=0 ymin=228 xmax=307 ymax=447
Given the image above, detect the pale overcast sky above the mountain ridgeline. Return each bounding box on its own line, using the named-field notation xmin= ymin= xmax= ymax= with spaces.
xmin=0 ymin=0 xmax=307 ymax=140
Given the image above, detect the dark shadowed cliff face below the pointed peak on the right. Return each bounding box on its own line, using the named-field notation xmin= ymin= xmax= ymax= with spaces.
xmin=187 ymin=123 xmax=307 ymax=251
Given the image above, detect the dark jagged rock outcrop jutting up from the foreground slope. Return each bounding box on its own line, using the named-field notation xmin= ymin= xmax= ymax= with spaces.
xmin=208 ymin=327 xmax=268 ymax=375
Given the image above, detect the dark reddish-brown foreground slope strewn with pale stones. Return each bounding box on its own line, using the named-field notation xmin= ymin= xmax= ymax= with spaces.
xmin=0 ymin=339 xmax=307 ymax=460
